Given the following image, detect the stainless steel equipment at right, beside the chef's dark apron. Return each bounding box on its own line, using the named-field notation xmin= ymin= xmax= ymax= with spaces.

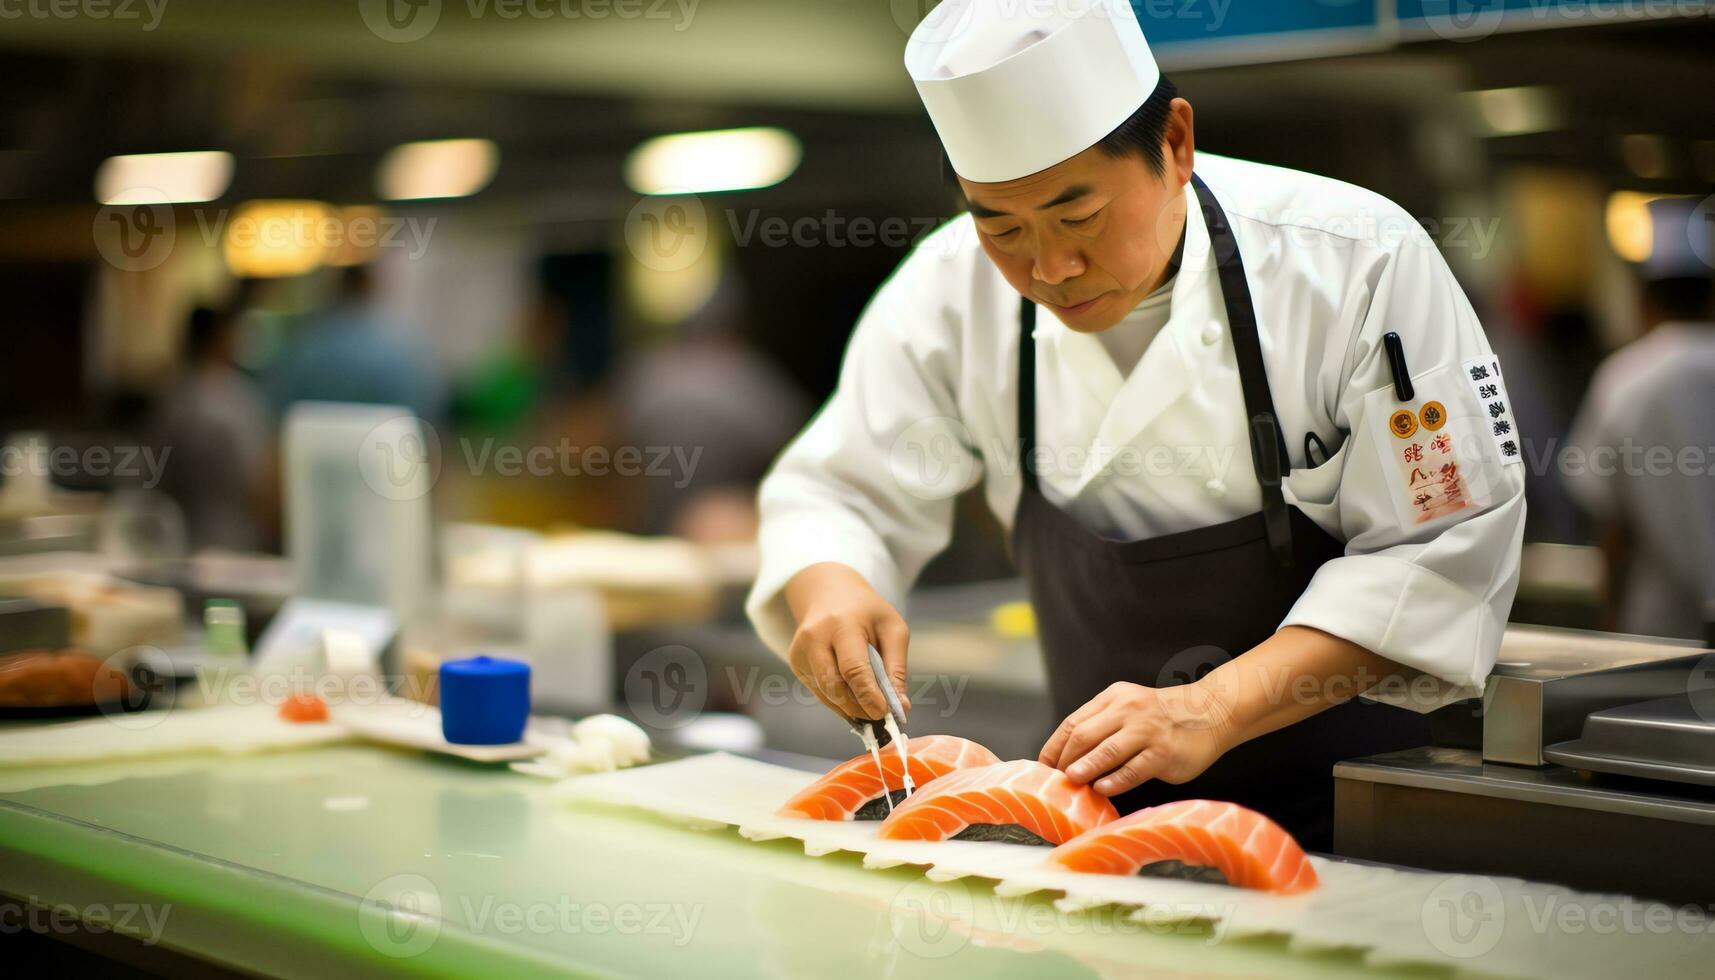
xmin=1334 ymin=626 xmax=1715 ymax=904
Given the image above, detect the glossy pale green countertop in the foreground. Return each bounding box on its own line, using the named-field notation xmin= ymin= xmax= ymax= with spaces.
xmin=0 ymin=745 xmax=1437 ymax=980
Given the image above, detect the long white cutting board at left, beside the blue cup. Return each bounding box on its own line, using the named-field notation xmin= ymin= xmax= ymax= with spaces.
xmin=0 ymin=699 xmax=547 ymax=769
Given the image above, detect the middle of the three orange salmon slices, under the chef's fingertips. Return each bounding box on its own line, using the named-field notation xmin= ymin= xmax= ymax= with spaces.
xmin=882 ymin=759 xmax=1120 ymax=844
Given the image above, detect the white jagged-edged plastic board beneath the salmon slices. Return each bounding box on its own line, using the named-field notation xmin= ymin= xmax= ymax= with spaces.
xmin=556 ymin=753 xmax=1715 ymax=978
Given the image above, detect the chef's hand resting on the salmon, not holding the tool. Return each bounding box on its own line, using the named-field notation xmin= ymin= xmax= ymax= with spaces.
xmin=1038 ymin=681 xmax=1231 ymax=796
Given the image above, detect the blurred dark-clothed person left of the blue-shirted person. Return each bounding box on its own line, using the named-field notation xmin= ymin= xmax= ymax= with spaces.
xmin=153 ymin=305 xmax=274 ymax=551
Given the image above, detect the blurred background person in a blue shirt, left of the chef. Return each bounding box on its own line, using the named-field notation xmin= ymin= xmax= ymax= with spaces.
xmin=264 ymin=264 xmax=446 ymax=422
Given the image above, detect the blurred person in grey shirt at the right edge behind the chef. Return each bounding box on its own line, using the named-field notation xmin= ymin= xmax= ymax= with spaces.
xmin=1568 ymin=199 xmax=1715 ymax=638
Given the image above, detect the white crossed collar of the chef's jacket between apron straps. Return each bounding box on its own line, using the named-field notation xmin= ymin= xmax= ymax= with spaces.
xmin=1036 ymin=175 xmax=1261 ymax=496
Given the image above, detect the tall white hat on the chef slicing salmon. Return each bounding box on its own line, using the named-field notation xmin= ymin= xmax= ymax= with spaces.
xmin=906 ymin=0 xmax=1161 ymax=184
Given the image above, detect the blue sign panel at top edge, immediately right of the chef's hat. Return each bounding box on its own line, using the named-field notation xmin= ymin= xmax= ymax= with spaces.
xmin=1132 ymin=0 xmax=1385 ymax=45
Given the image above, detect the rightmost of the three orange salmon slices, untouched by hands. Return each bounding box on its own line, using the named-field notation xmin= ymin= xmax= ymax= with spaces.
xmin=1048 ymin=800 xmax=1315 ymax=894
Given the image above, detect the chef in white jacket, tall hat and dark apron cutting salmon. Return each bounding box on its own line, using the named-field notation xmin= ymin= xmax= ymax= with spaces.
xmin=748 ymin=0 xmax=1525 ymax=850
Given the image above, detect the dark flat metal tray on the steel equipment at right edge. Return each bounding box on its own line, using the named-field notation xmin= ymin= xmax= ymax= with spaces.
xmin=1542 ymin=690 xmax=1715 ymax=786
